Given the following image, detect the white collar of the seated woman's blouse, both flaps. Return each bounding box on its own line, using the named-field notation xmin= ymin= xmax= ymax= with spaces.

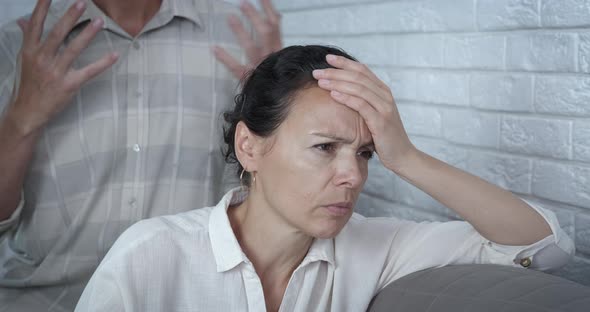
xmin=209 ymin=187 xmax=335 ymax=272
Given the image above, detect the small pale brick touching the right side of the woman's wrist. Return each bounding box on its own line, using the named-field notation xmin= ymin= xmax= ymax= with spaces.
xmin=397 ymin=103 xmax=442 ymax=137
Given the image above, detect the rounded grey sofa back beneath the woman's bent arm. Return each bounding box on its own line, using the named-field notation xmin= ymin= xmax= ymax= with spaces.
xmin=369 ymin=264 xmax=590 ymax=312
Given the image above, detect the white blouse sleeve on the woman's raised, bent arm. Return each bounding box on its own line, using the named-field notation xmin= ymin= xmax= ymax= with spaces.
xmin=379 ymin=203 xmax=574 ymax=288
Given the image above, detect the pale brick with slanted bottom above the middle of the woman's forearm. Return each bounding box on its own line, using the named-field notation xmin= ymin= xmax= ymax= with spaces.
xmin=466 ymin=151 xmax=532 ymax=194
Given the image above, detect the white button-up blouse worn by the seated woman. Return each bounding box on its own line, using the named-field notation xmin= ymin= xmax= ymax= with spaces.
xmin=76 ymin=189 xmax=574 ymax=312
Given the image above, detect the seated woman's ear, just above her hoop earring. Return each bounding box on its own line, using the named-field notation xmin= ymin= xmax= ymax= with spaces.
xmin=234 ymin=121 xmax=260 ymax=172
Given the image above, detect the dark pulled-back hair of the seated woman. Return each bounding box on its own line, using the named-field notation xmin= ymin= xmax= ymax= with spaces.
xmin=223 ymin=45 xmax=356 ymax=185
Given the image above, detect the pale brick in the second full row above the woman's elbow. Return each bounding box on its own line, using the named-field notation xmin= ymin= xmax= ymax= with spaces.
xmin=500 ymin=116 xmax=572 ymax=159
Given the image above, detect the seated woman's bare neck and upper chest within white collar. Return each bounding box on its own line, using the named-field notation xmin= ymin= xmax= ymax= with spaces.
xmin=228 ymin=194 xmax=313 ymax=298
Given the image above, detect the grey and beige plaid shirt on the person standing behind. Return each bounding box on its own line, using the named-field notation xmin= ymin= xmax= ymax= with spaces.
xmin=0 ymin=0 xmax=243 ymax=311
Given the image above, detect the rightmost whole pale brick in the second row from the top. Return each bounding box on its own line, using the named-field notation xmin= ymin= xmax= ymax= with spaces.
xmin=506 ymin=33 xmax=576 ymax=72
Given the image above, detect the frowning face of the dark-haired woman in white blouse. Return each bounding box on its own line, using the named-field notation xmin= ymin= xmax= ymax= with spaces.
xmin=254 ymin=87 xmax=374 ymax=238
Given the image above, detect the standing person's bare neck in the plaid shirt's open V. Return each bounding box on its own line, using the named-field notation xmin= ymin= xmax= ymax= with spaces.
xmin=92 ymin=0 xmax=163 ymax=37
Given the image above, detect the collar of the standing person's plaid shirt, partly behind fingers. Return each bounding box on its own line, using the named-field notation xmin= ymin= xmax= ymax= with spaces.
xmin=52 ymin=0 xmax=203 ymax=29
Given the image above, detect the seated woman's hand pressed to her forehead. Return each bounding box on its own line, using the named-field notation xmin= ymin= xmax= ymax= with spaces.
xmin=313 ymin=55 xmax=415 ymax=172
